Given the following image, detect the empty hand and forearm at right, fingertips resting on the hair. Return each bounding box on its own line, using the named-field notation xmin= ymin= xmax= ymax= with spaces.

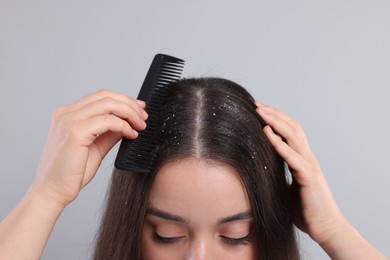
xmin=256 ymin=103 xmax=385 ymax=259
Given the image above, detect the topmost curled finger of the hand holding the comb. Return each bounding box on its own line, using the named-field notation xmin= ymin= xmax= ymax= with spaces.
xmin=67 ymin=89 xmax=147 ymax=120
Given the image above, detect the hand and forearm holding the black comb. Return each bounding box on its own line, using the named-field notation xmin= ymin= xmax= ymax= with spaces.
xmin=0 ymin=90 xmax=148 ymax=259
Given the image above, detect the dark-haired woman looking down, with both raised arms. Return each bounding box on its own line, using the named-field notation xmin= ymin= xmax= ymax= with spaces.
xmin=0 ymin=78 xmax=385 ymax=259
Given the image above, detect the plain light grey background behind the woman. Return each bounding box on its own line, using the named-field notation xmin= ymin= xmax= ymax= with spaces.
xmin=0 ymin=0 xmax=390 ymax=259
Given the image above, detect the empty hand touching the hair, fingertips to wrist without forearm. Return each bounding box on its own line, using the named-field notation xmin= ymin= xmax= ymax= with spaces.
xmin=256 ymin=103 xmax=346 ymax=244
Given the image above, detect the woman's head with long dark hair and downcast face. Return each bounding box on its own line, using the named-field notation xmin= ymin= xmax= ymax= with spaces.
xmin=95 ymin=78 xmax=298 ymax=259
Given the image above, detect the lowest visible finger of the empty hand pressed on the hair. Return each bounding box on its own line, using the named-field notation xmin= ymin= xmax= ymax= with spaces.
xmin=264 ymin=126 xmax=307 ymax=184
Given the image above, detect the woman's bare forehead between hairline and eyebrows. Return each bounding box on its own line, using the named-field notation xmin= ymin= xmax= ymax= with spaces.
xmin=148 ymin=157 xmax=251 ymax=223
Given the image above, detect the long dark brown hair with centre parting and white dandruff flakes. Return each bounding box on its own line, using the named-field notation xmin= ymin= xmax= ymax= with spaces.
xmin=94 ymin=78 xmax=299 ymax=260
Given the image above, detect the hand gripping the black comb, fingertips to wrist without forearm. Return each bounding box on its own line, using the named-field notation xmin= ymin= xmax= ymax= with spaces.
xmin=33 ymin=90 xmax=148 ymax=206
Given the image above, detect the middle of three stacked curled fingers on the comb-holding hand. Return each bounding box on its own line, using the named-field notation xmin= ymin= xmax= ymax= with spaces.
xmin=73 ymin=97 xmax=146 ymax=130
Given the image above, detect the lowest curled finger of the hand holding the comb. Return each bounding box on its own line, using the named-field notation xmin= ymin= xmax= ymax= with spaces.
xmin=75 ymin=114 xmax=138 ymax=146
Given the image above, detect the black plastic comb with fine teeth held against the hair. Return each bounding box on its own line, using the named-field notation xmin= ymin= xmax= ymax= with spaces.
xmin=115 ymin=54 xmax=184 ymax=173
